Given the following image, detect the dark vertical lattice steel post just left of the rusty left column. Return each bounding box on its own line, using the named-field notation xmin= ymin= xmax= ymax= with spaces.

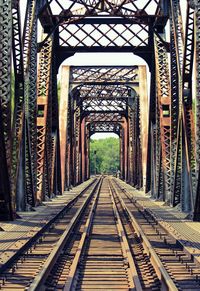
xmin=22 ymin=0 xmax=37 ymax=210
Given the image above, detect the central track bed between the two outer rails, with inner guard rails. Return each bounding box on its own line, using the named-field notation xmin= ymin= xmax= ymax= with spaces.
xmin=29 ymin=178 xmax=161 ymax=291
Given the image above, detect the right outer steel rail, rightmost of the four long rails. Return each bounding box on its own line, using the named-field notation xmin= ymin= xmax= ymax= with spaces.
xmin=111 ymin=181 xmax=178 ymax=291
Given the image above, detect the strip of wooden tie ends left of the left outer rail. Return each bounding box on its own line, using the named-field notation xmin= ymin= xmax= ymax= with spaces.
xmin=0 ymin=179 xmax=99 ymax=290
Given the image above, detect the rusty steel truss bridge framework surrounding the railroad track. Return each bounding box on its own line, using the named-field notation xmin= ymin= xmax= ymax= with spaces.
xmin=0 ymin=0 xmax=200 ymax=220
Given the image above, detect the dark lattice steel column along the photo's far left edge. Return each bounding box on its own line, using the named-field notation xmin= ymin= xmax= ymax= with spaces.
xmin=0 ymin=1 xmax=12 ymax=220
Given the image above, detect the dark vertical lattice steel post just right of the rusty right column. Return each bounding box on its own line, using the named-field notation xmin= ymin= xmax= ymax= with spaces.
xmin=171 ymin=1 xmax=185 ymax=210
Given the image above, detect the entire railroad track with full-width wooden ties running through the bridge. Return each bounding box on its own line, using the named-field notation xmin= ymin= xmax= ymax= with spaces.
xmin=0 ymin=177 xmax=200 ymax=291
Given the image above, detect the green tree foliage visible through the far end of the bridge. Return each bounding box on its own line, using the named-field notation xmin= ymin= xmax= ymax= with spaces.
xmin=90 ymin=137 xmax=119 ymax=174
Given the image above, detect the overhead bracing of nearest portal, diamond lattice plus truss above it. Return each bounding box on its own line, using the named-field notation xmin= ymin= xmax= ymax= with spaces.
xmin=40 ymin=0 xmax=166 ymax=51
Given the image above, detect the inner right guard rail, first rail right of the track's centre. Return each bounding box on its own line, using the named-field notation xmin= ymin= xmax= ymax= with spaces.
xmin=110 ymin=183 xmax=143 ymax=291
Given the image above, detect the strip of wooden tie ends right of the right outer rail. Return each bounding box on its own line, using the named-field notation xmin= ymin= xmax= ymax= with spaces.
xmin=115 ymin=181 xmax=200 ymax=290
